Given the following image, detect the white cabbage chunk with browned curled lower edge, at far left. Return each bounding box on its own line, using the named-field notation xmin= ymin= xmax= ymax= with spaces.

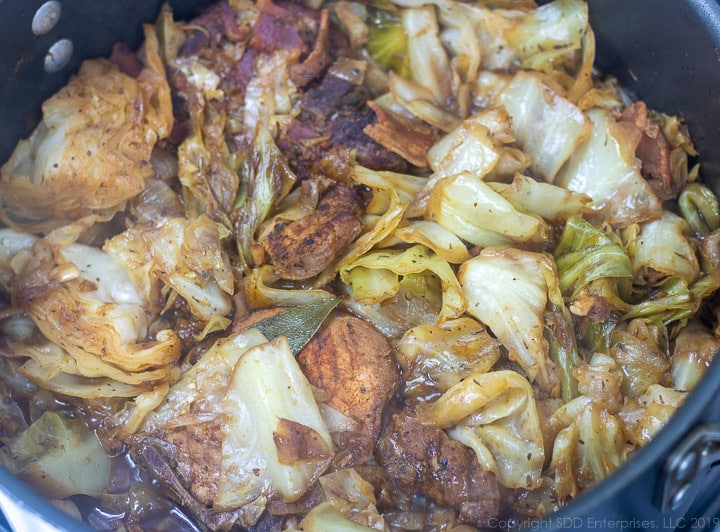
xmin=18 ymin=240 xmax=180 ymax=384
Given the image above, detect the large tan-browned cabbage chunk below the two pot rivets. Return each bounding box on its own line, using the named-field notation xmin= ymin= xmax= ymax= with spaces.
xmin=0 ymin=45 xmax=172 ymax=230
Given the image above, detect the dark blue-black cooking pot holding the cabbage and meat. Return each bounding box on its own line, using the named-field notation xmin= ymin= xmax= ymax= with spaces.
xmin=0 ymin=0 xmax=720 ymax=532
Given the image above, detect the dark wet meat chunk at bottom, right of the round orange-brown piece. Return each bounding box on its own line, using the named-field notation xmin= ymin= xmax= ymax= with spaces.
xmin=375 ymin=402 xmax=500 ymax=526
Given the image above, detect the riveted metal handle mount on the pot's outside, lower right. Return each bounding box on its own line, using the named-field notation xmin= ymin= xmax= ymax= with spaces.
xmin=657 ymin=421 xmax=720 ymax=514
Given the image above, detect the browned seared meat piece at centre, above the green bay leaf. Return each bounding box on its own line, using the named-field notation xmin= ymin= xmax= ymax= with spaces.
xmin=262 ymin=185 xmax=362 ymax=280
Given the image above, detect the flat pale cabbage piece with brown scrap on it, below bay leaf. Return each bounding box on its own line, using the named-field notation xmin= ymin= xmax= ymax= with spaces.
xmin=215 ymin=337 xmax=333 ymax=509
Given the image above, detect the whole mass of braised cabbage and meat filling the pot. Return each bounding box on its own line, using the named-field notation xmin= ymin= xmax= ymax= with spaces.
xmin=0 ymin=0 xmax=720 ymax=531
